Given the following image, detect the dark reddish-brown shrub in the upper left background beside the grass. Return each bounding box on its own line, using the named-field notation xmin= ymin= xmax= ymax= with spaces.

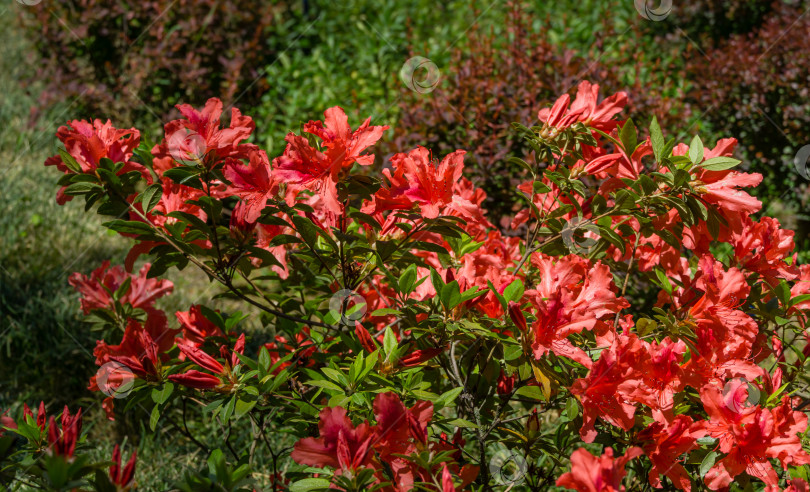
xmin=20 ymin=0 xmax=283 ymax=121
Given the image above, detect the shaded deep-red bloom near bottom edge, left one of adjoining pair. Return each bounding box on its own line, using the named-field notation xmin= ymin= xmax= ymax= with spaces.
xmin=290 ymin=407 xmax=375 ymax=472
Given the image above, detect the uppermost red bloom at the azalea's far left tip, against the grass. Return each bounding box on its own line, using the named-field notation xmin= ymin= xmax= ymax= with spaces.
xmin=45 ymin=120 xmax=145 ymax=205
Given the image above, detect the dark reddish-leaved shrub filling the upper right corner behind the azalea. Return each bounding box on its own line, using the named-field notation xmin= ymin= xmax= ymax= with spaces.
xmin=688 ymin=2 xmax=810 ymax=206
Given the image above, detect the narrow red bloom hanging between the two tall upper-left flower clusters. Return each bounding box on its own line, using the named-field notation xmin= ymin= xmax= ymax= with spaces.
xmin=224 ymin=150 xmax=278 ymax=223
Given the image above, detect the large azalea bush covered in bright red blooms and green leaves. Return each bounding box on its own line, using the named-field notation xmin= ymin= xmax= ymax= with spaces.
xmin=0 ymin=81 xmax=810 ymax=492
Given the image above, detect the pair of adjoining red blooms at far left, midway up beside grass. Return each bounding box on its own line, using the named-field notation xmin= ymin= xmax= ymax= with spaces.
xmin=68 ymin=260 xmax=174 ymax=314
